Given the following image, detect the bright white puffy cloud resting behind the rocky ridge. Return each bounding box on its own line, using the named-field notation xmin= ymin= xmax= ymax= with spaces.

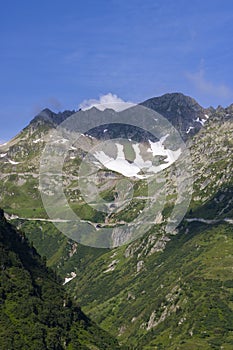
xmin=79 ymin=92 xmax=135 ymax=112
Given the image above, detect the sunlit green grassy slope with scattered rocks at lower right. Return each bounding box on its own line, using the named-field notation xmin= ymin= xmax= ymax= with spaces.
xmin=70 ymin=223 xmax=233 ymax=350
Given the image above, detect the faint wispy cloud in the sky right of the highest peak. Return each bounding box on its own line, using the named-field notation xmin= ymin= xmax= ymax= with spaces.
xmin=186 ymin=68 xmax=233 ymax=98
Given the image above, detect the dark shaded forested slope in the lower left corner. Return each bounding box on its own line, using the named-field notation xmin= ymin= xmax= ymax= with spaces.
xmin=0 ymin=210 xmax=118 ymax=350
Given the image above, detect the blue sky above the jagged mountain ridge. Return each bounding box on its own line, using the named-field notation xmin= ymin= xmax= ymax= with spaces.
xmin=0 ymin=0 xmax=233 ymax=140
